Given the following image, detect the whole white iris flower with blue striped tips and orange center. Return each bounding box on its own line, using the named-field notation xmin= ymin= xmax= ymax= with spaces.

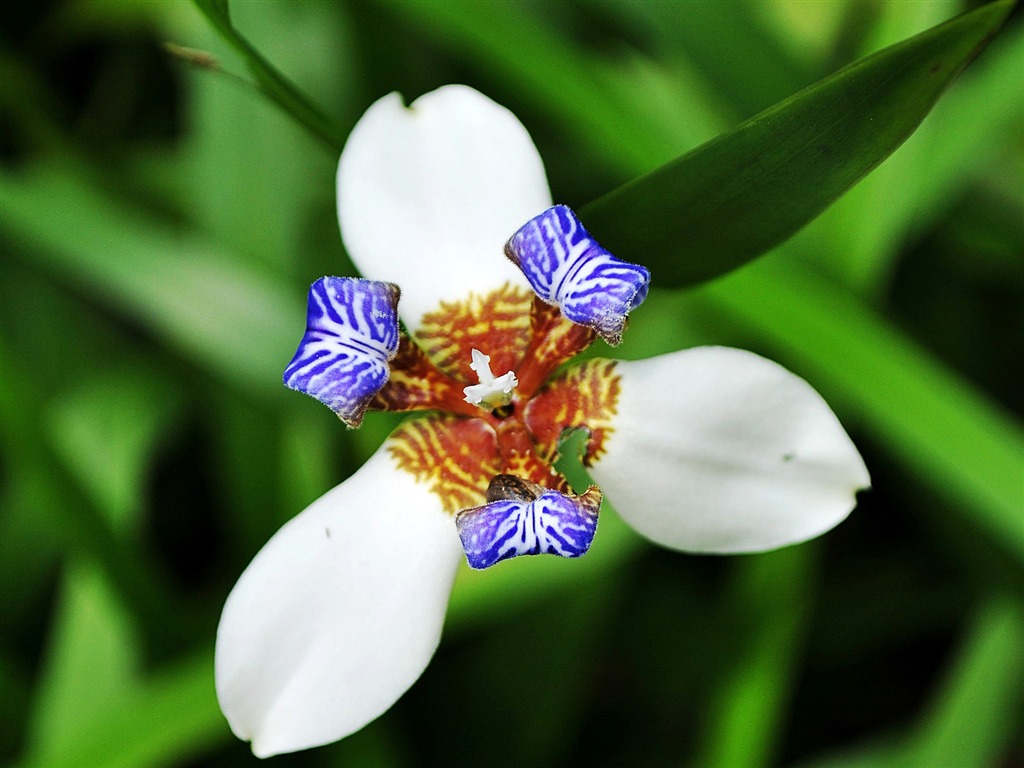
xmin=216 ymin=86 xmax=868 ymax=757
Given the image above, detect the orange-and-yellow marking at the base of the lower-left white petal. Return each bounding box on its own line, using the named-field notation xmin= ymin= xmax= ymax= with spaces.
xmin=389 ymin=416 xmax=501 ymax=514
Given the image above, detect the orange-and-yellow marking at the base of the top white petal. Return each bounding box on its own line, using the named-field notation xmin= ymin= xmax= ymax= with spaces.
xmin=416 ymin=284 xmax=534 ymax=384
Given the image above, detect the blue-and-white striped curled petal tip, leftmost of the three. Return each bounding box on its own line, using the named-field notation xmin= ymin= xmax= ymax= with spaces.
xmin=285 ymin=278 xmax=399 ymax=427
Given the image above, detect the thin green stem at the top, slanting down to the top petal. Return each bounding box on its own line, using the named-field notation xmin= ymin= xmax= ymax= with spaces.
xmin=193 ymin=0 xmax=345 ymax=154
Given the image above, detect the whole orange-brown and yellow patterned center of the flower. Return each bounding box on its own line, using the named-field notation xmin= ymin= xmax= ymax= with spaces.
xmin=372 ymin=286 xmax=618 ymax=513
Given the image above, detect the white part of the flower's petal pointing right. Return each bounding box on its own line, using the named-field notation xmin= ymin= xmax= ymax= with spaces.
xmin=592 ymin=347 xmax=870 ymax=553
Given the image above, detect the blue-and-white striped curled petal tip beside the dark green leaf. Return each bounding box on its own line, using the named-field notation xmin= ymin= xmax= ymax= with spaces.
xmin=505 ymin=206 xmax=650 ymax=344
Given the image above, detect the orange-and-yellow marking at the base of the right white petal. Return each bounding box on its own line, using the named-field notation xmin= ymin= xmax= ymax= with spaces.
xmin=523 ymin=358 xmax=621 ymax=466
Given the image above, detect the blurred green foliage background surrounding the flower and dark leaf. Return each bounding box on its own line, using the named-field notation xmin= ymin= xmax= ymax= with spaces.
xmin=0 ymin=0 xmax=1024 ymax=768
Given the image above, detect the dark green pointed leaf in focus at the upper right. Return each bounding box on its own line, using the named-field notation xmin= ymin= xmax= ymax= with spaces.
xmin=582 ymin=0 xmax=1013 ymax=287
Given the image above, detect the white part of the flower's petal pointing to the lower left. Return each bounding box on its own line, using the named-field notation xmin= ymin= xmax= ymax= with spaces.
xmin=216 ymin=443 xmax=462 ymax=757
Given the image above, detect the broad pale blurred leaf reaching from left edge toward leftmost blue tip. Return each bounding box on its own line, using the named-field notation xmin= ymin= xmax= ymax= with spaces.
xmin=0 ymin=164 xmax=304 ymax=394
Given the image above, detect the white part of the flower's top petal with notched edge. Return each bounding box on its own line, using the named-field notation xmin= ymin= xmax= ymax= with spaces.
xmin=338 ymin=85 xmax=551 ymax=330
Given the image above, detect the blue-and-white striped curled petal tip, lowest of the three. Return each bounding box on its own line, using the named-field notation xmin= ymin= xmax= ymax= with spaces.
xmin=456 ymin=475 xmax=601 ymax=568
